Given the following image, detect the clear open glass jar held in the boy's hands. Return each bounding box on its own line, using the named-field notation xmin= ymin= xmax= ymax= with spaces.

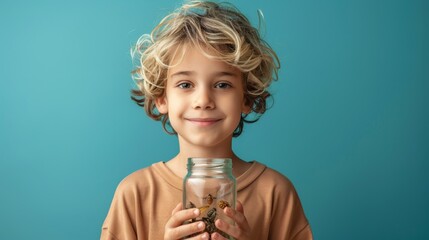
xmin=183 ymin=158 xmax=237 ymax=239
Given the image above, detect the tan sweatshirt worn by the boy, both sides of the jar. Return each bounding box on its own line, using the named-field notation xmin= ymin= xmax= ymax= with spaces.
xmin=100 ymin=162 xmax=313 ymax=240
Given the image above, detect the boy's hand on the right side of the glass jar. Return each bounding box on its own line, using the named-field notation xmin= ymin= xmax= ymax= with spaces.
xmin=211 ymin=201 xmax=251 ymax=240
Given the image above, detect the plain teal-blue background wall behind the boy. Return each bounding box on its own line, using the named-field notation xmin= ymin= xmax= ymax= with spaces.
xmin=0 ymin=0 xmax=429 ymax=239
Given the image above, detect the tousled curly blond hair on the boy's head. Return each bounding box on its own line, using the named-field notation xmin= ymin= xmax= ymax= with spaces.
xmin=131 ymin=1 xmax=280 ymax=137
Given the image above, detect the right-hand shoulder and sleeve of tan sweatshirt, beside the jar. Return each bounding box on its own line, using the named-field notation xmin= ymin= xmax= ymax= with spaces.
xmin=238 ymin=162 xmax=310 ymax=239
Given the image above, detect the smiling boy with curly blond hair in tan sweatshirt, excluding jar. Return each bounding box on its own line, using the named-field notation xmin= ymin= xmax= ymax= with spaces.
xmin=101 ymin=1 xmax=312 ymax=240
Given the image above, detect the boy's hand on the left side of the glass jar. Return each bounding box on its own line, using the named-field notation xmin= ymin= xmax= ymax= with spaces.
xmin=164 ymin=203 xmax=209 ymax=240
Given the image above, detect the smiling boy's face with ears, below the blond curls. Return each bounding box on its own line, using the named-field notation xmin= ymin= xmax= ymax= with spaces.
xmin=155 ymin=44 xmax=250 ymax=147
